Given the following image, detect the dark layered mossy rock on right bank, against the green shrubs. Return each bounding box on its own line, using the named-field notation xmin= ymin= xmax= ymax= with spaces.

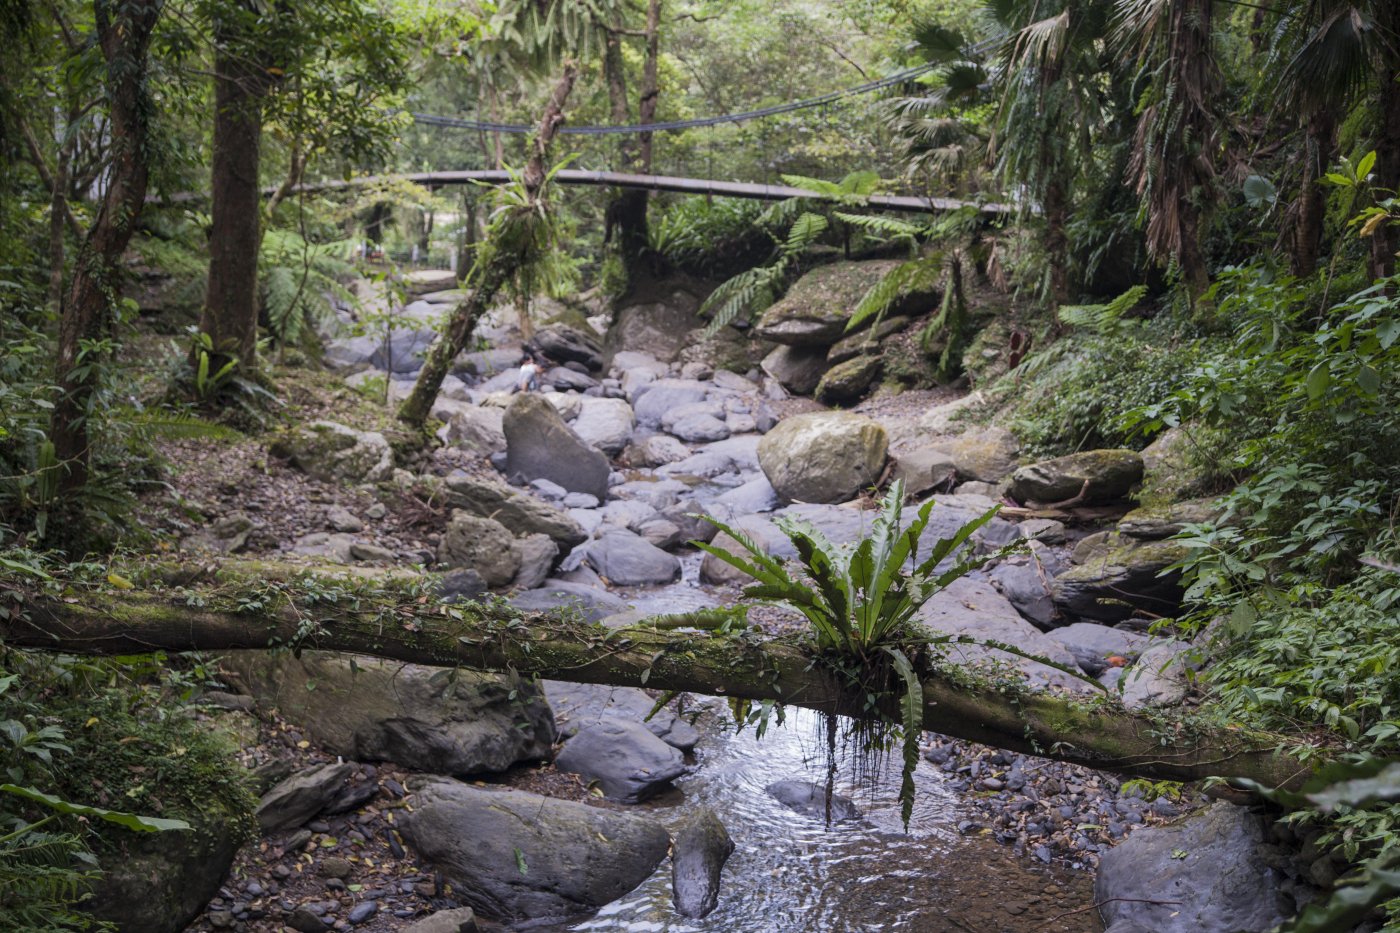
xmin=1051 ymin=535 xmax=1187 ymax=622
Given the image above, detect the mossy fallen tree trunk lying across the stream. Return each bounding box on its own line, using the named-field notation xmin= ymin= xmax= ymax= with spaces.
xmin=0 ymin=565 xmax=1310 ymax=786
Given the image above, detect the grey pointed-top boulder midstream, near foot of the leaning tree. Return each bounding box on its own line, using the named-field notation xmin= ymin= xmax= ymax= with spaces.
xmin=503 ymin=392 xmax=610 ymax=500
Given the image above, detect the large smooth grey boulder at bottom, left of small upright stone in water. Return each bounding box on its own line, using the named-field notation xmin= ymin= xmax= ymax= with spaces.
xmin=402 ymin=778 xmax=671 ymax=923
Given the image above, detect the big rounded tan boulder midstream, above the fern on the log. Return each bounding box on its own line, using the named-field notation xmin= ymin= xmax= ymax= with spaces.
xmin=759 ymin=412 xmax=888 ymax=503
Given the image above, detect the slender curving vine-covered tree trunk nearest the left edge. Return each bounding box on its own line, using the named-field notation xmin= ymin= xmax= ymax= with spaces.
xmin=49 ymin=0 xmax=162 ymax=492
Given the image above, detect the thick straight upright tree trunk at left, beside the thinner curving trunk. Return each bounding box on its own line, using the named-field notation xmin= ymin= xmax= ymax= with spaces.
xmin=199 ymin=42 xmax=267 ymax=371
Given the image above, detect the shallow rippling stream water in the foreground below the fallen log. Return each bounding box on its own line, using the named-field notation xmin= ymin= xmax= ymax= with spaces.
xmin=557 ymin=703 xmax=1102 ymax=933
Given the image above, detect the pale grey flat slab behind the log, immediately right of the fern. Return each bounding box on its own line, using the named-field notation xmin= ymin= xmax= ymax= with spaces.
xmin=914 ymin=577 xmax=1093 ymax=692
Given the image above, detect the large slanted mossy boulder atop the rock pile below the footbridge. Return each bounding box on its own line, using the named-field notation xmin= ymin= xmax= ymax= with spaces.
xmin=755 ymin=259 xmax=934 ymax=347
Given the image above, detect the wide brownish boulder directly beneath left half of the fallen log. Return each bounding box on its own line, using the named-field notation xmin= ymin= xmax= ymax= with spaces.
xmin=223 ymin=650 xmax=554 ymax=775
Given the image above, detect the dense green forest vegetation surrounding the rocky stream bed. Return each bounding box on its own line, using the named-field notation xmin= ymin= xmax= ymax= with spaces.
xmin=0 ymin=0 xmax=1400 ymax=929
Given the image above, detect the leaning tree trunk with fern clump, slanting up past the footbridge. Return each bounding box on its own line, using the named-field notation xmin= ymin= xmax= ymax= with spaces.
xmin=399 ymin=62 xmax=578 ymax=429
